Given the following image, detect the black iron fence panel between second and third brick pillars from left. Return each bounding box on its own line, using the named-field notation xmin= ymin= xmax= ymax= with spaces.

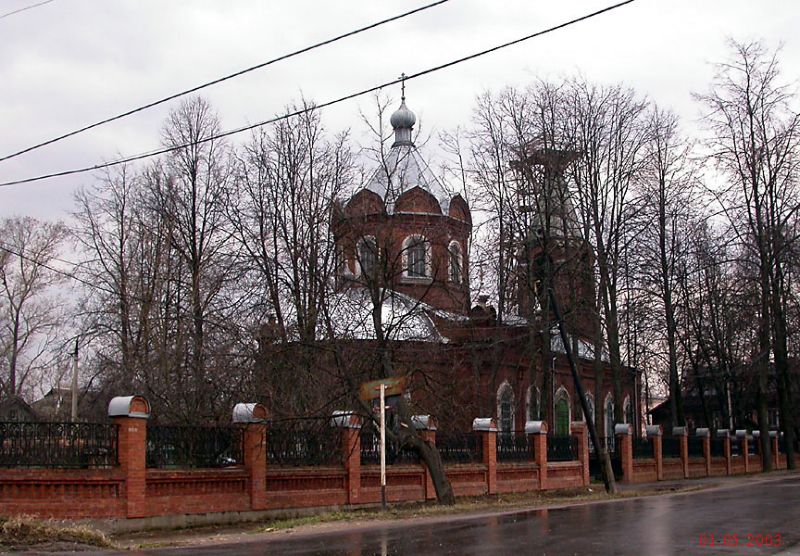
xmin=267 ymin=418 xmax=344 ymax=466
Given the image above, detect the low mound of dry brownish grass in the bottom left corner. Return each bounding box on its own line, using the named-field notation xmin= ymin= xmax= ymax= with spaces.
xmin=0 ymin=515 xmax=115 ymax=549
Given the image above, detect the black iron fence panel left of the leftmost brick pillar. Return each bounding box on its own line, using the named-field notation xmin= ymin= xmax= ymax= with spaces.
xmin=0 ymin=421 xmax=119 ymax=468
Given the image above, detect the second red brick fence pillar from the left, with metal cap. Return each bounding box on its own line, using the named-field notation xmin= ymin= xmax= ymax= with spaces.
xmin=233 ymin=403 xmax=267 ymax=510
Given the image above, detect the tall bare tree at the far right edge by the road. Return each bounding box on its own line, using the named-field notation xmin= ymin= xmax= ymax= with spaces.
xmin=697 ymin=41 xmax=800 ymax=470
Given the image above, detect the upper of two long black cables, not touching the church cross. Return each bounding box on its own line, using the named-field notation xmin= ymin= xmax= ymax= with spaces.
xmin=0 ymin=0 xmax=450 ymax=162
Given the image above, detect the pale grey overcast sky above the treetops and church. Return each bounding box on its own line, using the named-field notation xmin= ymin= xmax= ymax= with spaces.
xmin=0 ymin=0 xmax=800 ymax=219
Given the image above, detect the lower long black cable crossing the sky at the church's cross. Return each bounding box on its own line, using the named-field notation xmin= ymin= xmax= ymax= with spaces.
xmin=0 ymin=0 xmax=635 ymax=187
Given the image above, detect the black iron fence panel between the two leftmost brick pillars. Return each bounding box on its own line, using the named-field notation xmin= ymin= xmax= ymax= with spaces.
xmin=147 ymin=425 xmax=244 ymax=469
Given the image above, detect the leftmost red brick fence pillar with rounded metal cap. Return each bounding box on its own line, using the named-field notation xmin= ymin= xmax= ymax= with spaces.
xmin=108 ymin=396 xmax=150 ymax=517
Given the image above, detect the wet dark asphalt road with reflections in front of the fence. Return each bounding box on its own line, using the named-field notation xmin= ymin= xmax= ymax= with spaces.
xmin=127 ymin=476 xmax=800 ymax=556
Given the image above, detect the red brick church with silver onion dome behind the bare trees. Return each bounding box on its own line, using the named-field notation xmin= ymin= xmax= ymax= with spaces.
xmin=324 ymin=92 xmax=641 ymax=436
